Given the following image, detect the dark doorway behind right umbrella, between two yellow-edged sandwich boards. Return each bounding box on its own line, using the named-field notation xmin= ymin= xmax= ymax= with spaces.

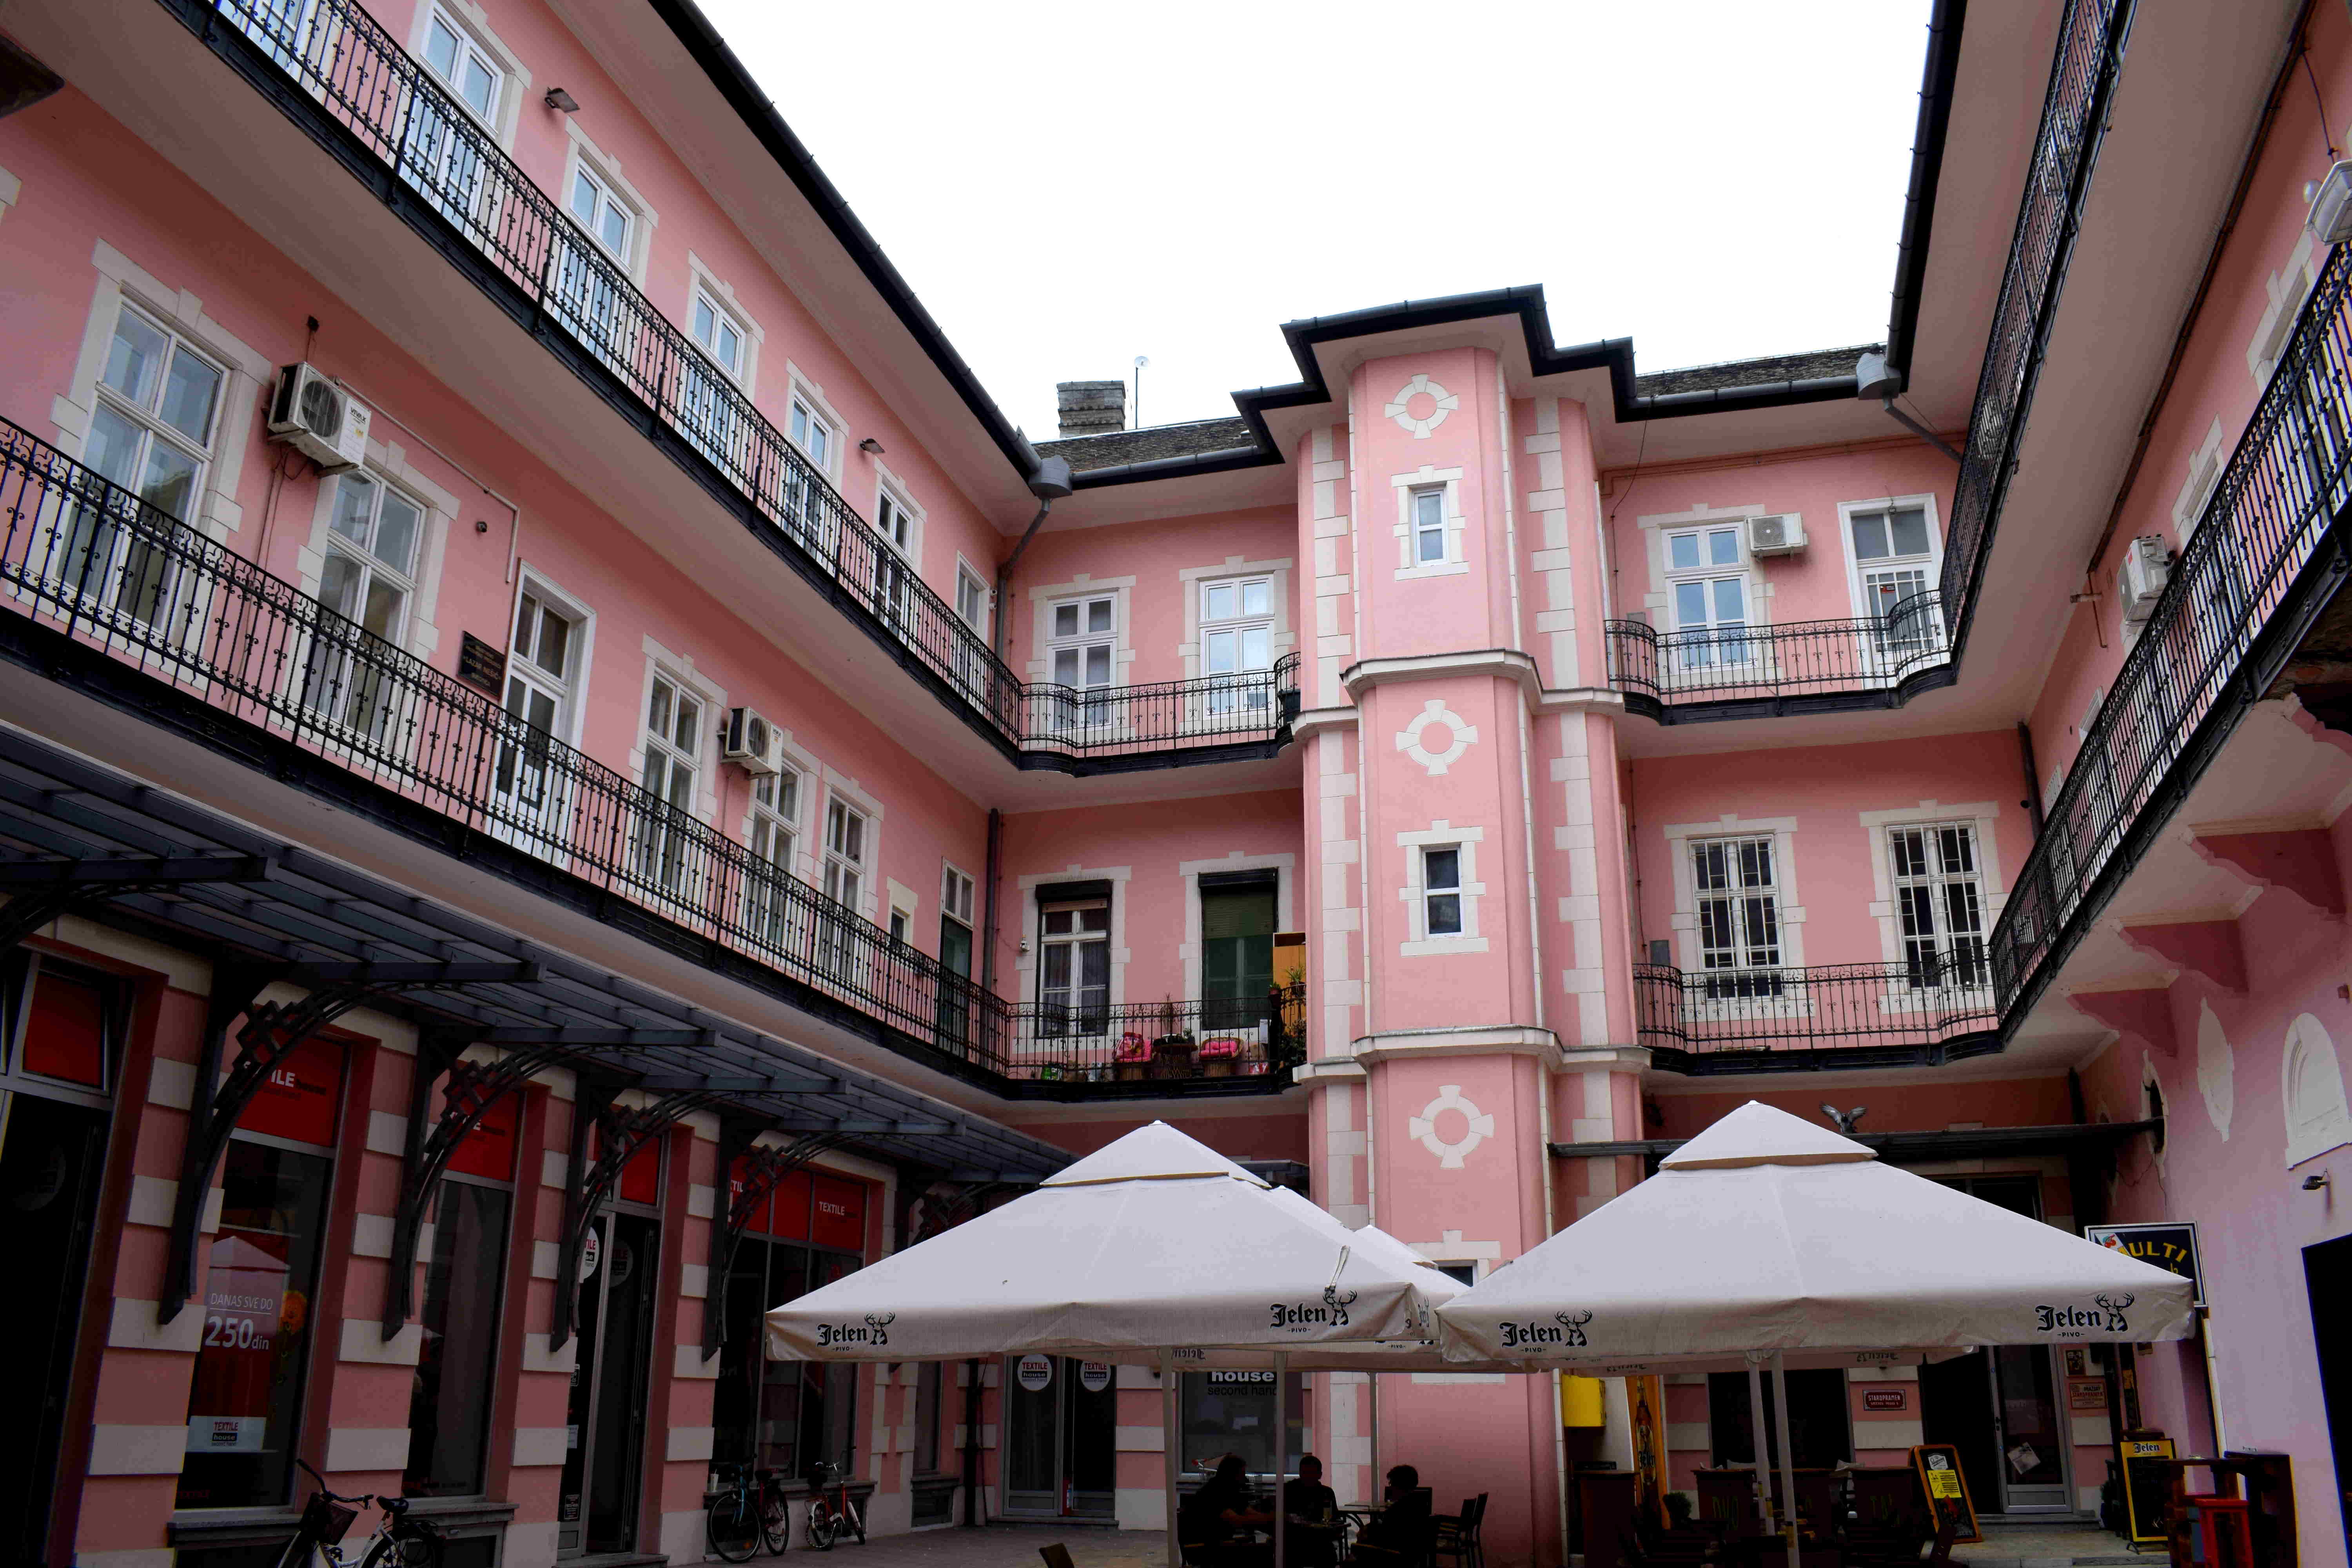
xmin=1919 ymin=1176 xmax=2074 ymax=1514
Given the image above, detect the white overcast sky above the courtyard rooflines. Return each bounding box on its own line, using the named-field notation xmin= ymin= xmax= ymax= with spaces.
xmin=703 ymin=0 xmax=1929 ymax=439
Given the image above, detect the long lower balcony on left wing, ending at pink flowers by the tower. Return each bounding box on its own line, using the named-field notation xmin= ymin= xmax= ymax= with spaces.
xmin=0 ymin=421 xmax=1301 ymax=1098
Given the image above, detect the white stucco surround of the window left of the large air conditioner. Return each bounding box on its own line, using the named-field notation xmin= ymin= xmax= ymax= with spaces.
xmin=49 ymin=240 xmax=278 ymax=543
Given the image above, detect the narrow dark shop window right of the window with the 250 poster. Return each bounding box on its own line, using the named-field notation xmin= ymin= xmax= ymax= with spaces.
xmin=402 ymin=1182 xmax=513 ymax=1497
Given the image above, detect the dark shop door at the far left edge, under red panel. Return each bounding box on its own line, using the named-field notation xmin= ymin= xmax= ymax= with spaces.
xmin=0 ymin=1093 xmax=106 ymax=1563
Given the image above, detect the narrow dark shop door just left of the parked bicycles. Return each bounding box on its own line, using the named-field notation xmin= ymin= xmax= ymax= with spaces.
xmin=555 ymin=1213 xmax=661 ymax=1556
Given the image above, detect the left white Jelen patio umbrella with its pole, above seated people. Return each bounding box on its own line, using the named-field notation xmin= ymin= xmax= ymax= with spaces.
xmin=767 ymin=1122 xmax=1454 ymax=1566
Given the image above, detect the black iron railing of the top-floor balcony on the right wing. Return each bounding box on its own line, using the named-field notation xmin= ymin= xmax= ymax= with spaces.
xmin=1940 ymin=0 xmax=2138 ymax=644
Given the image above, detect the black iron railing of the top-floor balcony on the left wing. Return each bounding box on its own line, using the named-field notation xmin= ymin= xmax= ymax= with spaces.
xmin=162 ymin=0 xmax=1298 ymax=771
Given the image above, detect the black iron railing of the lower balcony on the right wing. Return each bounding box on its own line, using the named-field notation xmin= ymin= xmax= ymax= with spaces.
xmin=1992 ymin=232 xmax=2352 ymax=1018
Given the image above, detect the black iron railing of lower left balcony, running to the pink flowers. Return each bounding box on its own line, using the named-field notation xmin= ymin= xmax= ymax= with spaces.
xmin=0 ymin=421 xmax=1298 ymax=1100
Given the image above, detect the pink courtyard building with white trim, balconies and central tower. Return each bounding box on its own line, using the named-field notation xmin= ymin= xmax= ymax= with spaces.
xmin=0 ymin=0 xmax=2352 ymax=1568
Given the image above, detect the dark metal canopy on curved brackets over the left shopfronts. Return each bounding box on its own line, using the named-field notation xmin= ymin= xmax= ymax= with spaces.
xmin=0 ymin=731 xmax=1068 ymax=1185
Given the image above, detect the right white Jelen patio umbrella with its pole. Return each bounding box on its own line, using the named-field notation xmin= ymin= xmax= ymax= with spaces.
xmin=1437 ymin=1100 xmax=2192 ymax=1568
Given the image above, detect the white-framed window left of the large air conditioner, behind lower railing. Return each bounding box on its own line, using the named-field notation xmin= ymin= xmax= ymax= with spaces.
xmin=65 ymin=301 xmax=228 ymax=628
